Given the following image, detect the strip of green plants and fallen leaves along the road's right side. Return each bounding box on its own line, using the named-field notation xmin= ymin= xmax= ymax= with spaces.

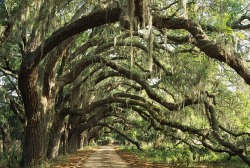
xmin=118 ymin=146 xmax=248 ymax=168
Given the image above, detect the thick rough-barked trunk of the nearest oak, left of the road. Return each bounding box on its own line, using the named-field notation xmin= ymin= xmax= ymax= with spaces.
xmin=18 ymin=67 xmax=47 ymax=167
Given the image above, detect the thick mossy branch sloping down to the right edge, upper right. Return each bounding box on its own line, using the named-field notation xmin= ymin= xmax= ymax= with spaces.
xmin=153 ymin=15 xmax=250 ymax=85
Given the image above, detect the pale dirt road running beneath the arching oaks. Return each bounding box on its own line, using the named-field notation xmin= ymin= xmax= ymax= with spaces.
xmin=83 ymin=146 xmax=128 ymax=168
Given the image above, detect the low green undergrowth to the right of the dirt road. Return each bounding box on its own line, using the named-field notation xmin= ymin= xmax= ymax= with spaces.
xmin=122 ymin=145 xmax=247 ymax=168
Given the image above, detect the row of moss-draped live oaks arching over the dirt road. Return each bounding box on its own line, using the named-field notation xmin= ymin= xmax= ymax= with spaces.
xmin=0 ymin=0 xmax=250 ymax=167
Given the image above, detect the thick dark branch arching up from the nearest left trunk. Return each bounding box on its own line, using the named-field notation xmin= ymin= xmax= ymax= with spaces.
xmin=26 ymin=8 xmax=122 ymax=68
